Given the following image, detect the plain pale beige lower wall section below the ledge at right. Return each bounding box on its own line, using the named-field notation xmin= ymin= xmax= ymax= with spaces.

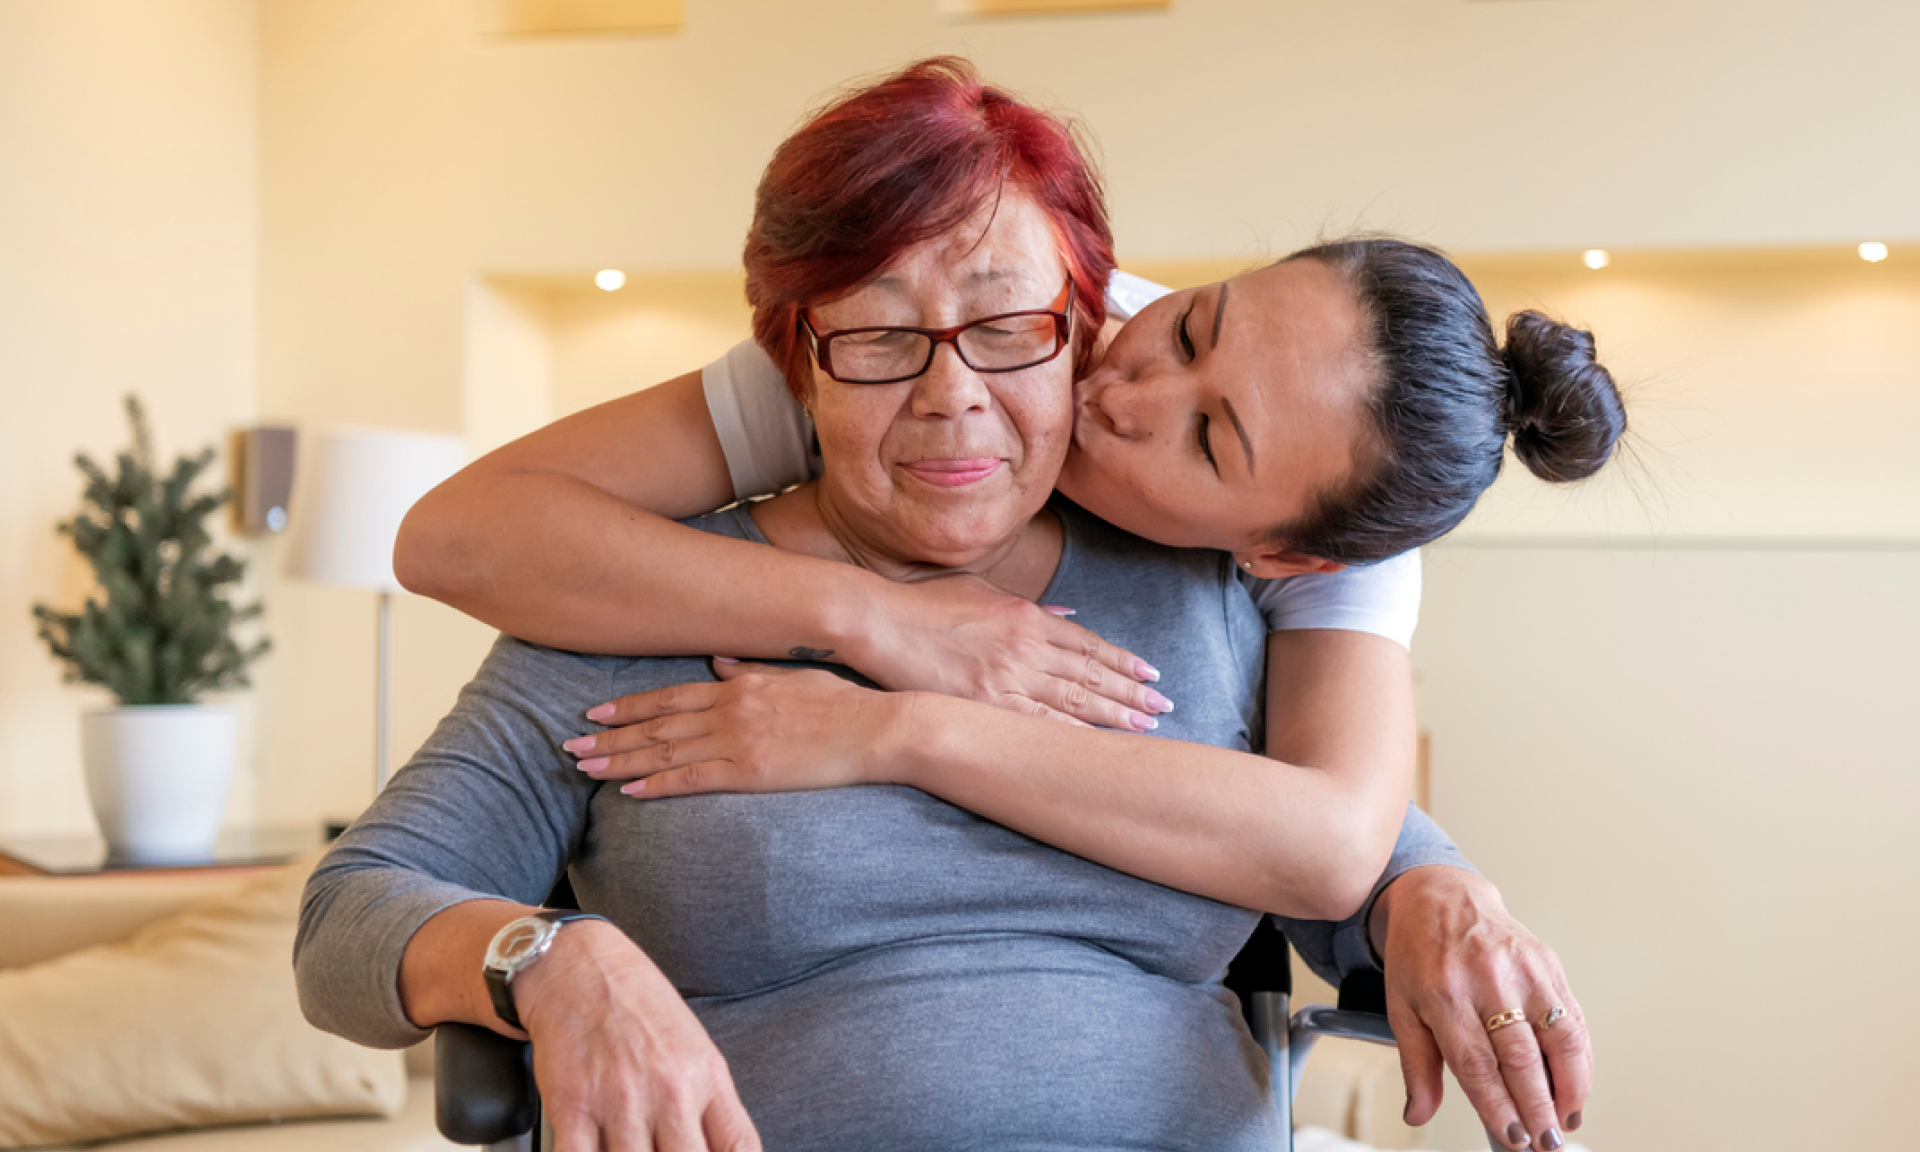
xmin=1415 ymin=545 xmax=1920 ymax=1152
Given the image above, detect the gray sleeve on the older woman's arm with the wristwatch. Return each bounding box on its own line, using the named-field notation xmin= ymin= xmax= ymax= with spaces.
xmin=294 ymin=637 xmax=612 ymax=1048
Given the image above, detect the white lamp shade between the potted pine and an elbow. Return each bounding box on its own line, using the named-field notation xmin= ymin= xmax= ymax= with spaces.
xmin=286 ymin=428 xmax=467 ymax=591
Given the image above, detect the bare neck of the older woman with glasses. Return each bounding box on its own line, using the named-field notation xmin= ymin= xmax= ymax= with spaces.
xmin=749 ymin=480 xmax=1062 ymax=599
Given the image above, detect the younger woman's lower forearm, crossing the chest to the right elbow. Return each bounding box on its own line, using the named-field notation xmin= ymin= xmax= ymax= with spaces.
xmin=883 ymin=693 xmax=1379 ymax=920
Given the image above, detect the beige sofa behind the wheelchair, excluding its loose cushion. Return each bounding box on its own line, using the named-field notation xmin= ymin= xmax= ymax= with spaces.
xmin=0 ymin=872 xmax=1419 ymax=1152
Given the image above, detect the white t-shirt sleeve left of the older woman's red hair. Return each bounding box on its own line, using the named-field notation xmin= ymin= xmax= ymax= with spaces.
xmin=701 ymin=340 xmax=820 ymax=499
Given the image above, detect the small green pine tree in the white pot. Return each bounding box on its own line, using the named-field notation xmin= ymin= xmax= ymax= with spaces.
xmin=33 ymin=396 xmax=269 ymax=705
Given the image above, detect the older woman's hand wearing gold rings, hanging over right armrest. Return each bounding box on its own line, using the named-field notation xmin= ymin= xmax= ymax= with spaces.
xmin=1371 ymin=868 xmax=1594 ymax=1150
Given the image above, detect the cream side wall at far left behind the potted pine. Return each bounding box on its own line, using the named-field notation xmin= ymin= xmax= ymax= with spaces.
xmin=0 ymin=0 xmax=259 ymax=833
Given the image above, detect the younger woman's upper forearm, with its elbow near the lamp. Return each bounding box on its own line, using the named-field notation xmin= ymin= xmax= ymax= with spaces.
xmin=401 ymin=472 xmax=891 ymax=659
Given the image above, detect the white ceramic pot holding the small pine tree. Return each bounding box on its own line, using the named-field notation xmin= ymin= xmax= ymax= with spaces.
xmin=81 ymin=705 xmax=234 ymax=864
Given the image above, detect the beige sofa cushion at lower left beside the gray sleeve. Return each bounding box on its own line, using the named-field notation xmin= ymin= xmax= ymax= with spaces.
xmin=0 ymin=852 xmax=407 ymax=1148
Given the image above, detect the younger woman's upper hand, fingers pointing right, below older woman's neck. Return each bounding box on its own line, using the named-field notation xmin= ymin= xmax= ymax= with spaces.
xmin=847 ymin=576 xmax=1173 ymax=732
